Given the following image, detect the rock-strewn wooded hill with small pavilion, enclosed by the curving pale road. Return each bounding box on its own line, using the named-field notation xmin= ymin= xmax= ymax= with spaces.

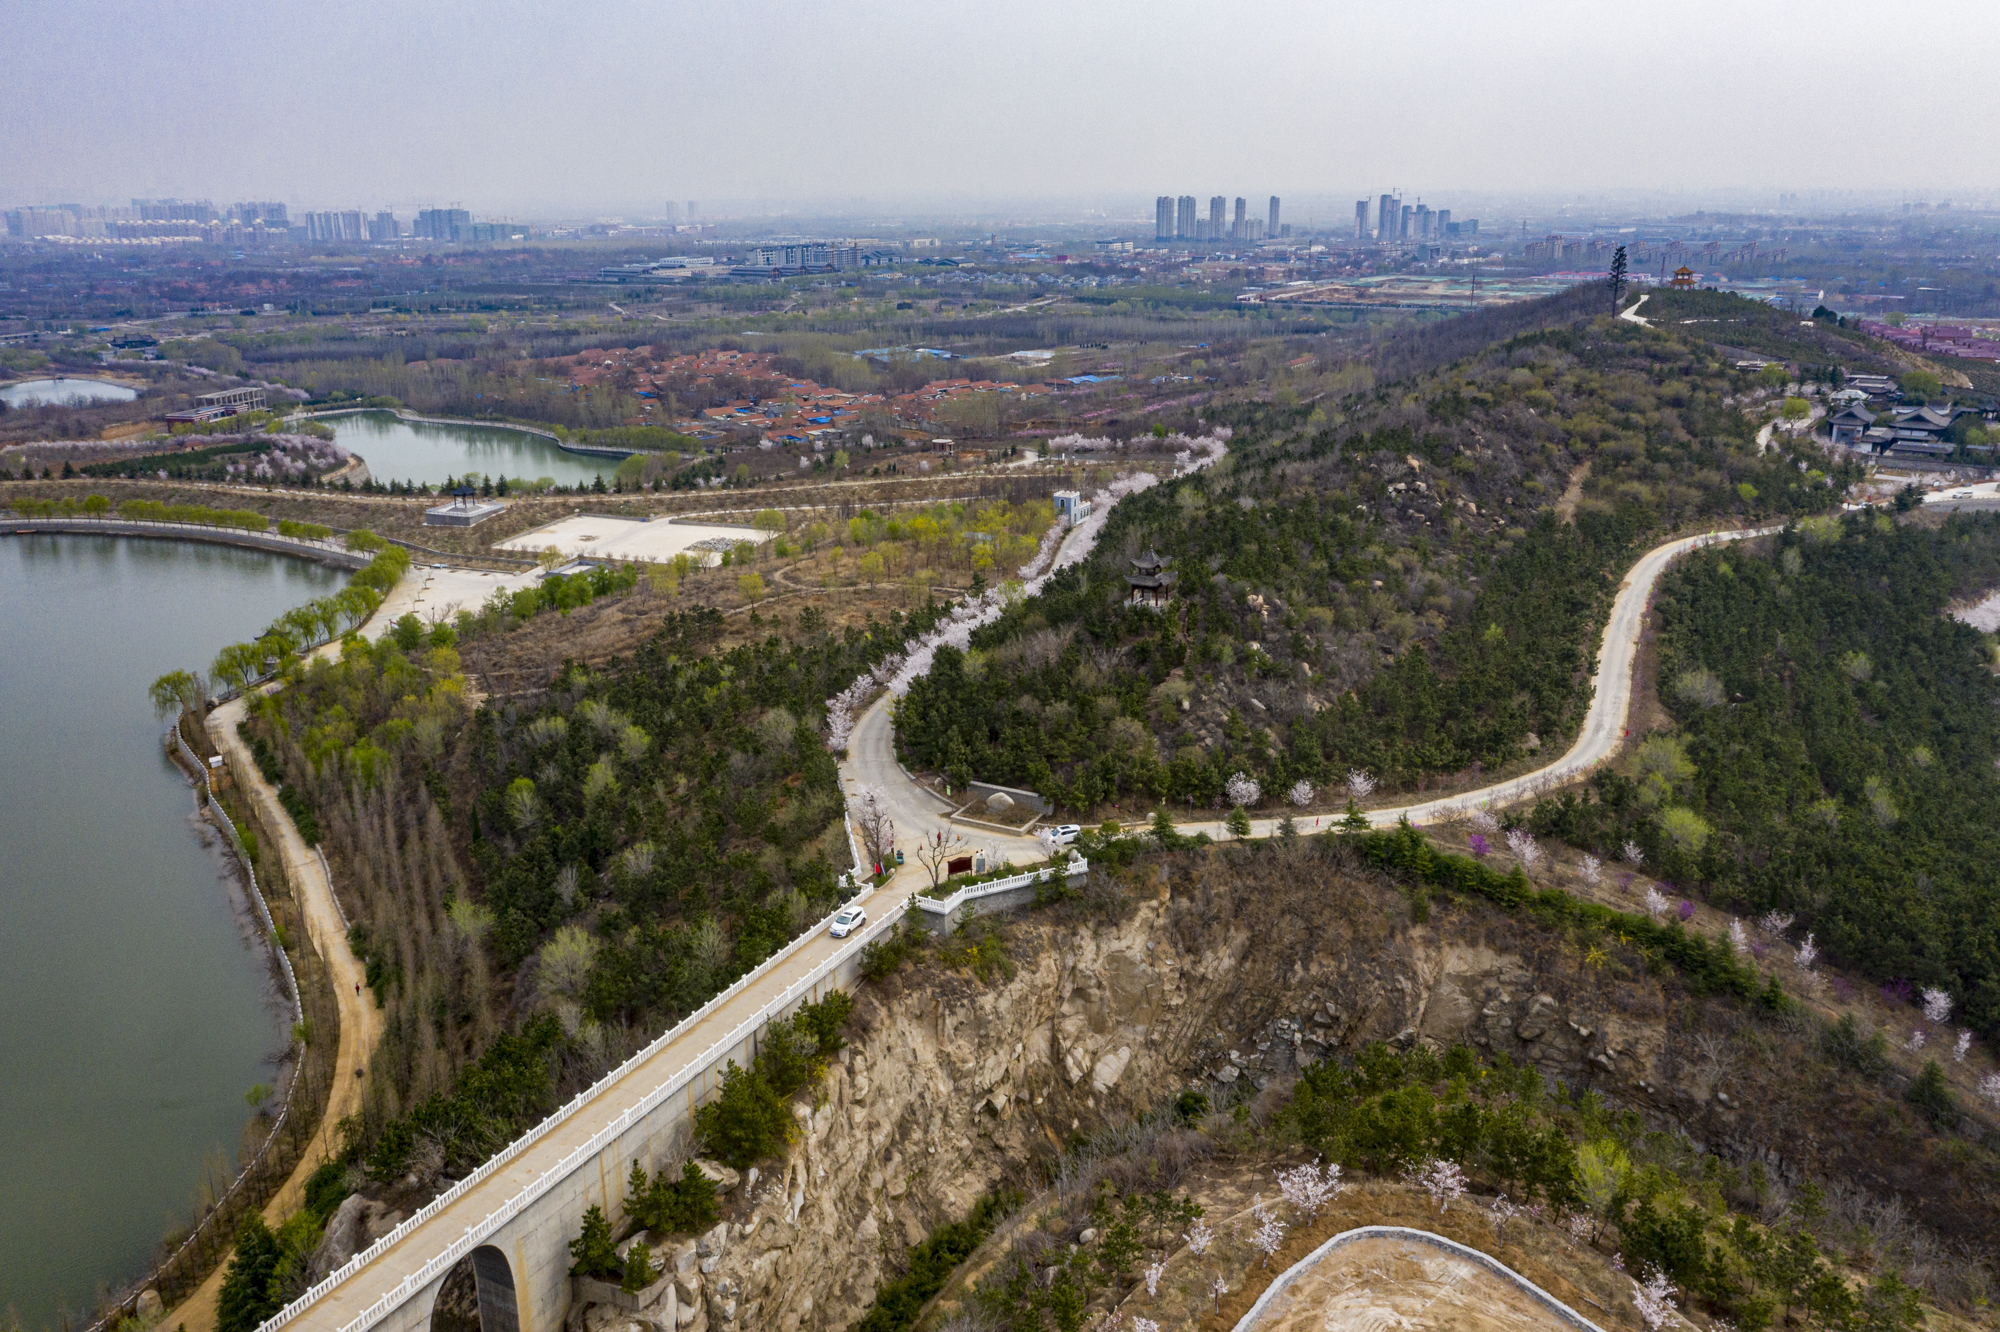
xmin=898 ymin=318 xmax=1852 ymax=810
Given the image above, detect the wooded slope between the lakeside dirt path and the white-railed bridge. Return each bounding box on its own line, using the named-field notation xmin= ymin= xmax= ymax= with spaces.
xmin=250 ymin=586 xmax=936 ymax=1184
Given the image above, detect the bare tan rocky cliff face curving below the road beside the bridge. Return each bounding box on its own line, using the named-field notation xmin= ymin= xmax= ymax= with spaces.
xmin=584 ymin=850 xmax=1976 ymax=1332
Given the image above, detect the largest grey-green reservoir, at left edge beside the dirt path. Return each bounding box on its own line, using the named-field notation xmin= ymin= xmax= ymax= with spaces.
xmin=0 ymin=534 xmax=346 ymax=1332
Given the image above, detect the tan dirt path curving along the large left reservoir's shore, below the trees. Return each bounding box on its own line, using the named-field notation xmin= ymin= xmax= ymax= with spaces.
xmin=162 ymin=688 xmax=386 ymax=1332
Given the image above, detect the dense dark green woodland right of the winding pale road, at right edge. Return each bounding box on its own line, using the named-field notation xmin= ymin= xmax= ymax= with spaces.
xmin=1534 ymin=514 xmax=2000 ymax=1034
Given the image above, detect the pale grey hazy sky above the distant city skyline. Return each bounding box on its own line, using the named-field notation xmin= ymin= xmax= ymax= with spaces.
xmin=0 ymin=0 xmax=2000 ymax=216
